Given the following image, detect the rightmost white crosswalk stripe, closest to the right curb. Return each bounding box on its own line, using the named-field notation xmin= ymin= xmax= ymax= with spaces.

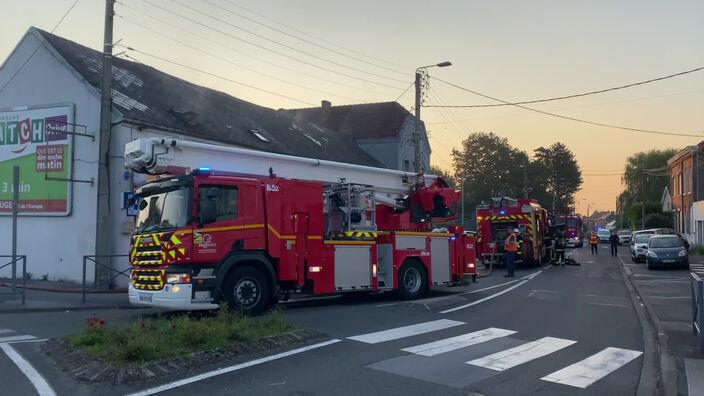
xmin=541 ymin=348 xmax=643 ymax=389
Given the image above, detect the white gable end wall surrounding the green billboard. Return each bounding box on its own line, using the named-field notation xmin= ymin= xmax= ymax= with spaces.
xmin=0 ymin=32 xmax=100 ymax=281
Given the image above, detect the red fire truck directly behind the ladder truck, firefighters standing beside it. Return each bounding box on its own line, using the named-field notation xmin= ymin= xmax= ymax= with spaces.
xmin=477 ymin=197 xmax=548 ymax=267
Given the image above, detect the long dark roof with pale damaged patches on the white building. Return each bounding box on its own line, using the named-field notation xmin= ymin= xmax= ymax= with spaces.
xmin=32 ymin=28 xmax=383 ymax=167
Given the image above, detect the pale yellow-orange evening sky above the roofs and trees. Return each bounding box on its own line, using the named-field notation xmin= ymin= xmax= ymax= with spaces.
xmin=0 ymin=0 xmax=704 ymax=213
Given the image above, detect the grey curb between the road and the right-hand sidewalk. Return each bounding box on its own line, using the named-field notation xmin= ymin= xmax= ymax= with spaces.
xmin=619 ymin=257 xmax=677 ymax=396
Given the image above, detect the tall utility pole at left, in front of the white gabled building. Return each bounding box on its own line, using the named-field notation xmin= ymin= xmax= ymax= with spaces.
xmin=95 ymin=0 xmax=115 ymax=283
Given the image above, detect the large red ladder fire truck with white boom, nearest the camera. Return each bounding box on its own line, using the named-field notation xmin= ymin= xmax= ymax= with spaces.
xmin=125 ymin=138 xmax=476 ymax=313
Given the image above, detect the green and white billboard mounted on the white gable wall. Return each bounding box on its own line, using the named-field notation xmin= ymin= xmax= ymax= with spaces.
xmin=0 ymin=105 xmax=73 ymax=216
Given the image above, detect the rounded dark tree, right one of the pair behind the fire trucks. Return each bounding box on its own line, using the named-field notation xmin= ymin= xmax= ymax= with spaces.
xmin=534 ymin=142 xmax=583 ymax=209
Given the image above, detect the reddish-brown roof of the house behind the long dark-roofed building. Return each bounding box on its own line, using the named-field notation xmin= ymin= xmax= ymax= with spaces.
xmin=281 ymin=102 xmax=414 ymax=139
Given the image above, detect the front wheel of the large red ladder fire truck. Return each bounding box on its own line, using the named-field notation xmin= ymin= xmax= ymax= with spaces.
xmin=223 ymin=267 xmax=271 ymax=315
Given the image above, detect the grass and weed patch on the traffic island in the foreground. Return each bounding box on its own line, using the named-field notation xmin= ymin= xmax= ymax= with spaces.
xmin=66 ymin=305 xmax=291 ymax=364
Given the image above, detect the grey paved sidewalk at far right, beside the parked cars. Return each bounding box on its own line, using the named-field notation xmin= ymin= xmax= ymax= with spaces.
xmin=620 ymin=252 xmax=704 ymax=395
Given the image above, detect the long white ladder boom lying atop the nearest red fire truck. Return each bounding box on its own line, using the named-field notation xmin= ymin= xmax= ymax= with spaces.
xmin=125 ymin=138 xmax=437 ymax=196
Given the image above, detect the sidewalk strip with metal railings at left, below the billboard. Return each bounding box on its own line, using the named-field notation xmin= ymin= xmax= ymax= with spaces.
xmin=0 ymin=279 xmax=139 ymax=315
